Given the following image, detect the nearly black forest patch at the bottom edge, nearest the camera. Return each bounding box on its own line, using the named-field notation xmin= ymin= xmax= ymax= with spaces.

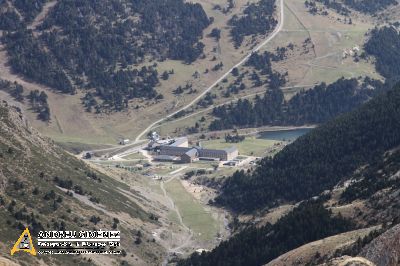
xmin=178 ymin=202 xmax=353 ymax=266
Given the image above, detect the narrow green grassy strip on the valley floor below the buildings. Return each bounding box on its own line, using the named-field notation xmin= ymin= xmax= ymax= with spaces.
xmin=165 ymin=179 xmax=219 ymax=240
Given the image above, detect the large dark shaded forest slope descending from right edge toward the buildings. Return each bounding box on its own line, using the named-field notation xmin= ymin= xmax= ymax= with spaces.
xmin=216 ymin=86 xmax=400 ymax=211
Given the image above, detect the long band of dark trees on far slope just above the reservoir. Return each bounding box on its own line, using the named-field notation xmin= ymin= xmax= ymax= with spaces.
xmin=209 ymin=78 xmax=384 ymax=130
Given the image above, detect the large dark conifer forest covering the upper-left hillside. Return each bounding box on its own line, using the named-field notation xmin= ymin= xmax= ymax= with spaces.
xmin=0 ymin=0 xmax=210 ymax=110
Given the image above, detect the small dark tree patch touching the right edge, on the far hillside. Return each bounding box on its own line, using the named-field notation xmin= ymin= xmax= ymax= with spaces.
xmin=364 ymin=27 xmax=400 ymax=80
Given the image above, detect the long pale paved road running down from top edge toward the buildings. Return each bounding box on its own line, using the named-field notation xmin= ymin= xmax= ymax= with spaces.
xmin=135 ymin=0 xmax=285 ymax=141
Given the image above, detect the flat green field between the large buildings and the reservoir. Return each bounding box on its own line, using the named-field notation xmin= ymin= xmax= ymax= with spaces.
xmin=201 ymin=137 xmax=276 ymax=156
